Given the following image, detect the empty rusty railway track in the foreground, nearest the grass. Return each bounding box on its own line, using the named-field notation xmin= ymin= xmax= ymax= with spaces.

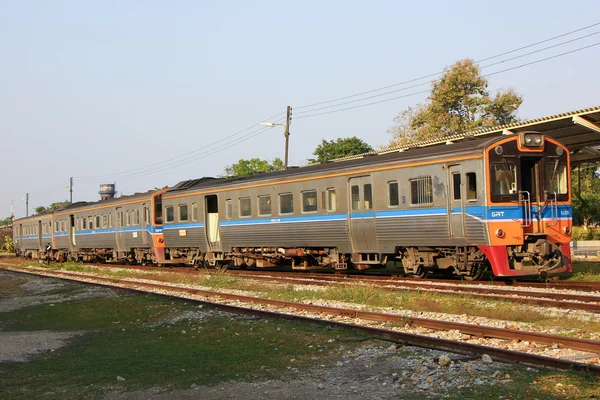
xmin=4 ymin=267 xmax=600 ymax=376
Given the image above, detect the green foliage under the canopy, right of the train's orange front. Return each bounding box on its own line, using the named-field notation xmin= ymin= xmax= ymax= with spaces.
xmin=571 ymin=163 xmax=600 ymax=229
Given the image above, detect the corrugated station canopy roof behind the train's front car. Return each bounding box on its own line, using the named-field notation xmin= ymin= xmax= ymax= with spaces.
xmin=334 ymin=106 xmax=600 ymax=166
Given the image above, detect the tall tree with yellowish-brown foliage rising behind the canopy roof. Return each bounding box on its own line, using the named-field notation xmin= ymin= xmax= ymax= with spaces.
xmin=388 ymin=59 xmax=523 ymax=146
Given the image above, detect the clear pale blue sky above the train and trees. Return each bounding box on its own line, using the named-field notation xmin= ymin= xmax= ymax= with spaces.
xmin=0 ymin=0 xmax=600 ymax=219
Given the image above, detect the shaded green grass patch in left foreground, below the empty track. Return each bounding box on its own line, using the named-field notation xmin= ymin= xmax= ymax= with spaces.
xmin=0 ymin=295 xmax=368 ymax=399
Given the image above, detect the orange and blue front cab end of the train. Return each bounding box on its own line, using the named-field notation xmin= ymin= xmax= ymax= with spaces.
xmin=479 ymin=132 xmax=572 ymax=277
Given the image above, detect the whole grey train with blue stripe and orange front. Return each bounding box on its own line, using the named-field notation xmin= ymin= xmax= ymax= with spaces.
xmin=13 ymin=132 xmax=572 ymax=280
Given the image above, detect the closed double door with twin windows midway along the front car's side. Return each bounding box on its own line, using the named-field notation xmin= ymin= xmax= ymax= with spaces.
xmin=348 ymin=176 xmax=377 ymax=252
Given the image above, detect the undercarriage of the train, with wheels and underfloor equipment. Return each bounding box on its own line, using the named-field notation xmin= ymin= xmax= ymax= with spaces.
xmin=21 ymin=235 xmax=565 ymax=280
